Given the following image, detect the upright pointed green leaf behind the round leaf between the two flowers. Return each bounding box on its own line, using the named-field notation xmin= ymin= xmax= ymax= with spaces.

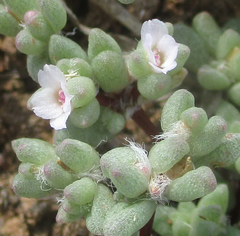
xmin=88 ymin=28 xmax=121 ymax=61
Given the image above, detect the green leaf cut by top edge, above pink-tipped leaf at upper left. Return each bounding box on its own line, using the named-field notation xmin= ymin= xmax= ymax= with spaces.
xmin=4 ymin=0 xmax=38 ymax=21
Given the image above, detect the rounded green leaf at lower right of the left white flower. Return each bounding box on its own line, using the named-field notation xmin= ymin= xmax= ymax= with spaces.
xmin=69 ymin=98 xmax=100 ymax=128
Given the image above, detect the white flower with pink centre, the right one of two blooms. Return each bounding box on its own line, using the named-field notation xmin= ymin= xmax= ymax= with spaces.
xmin=141 ymin=19 xmax=178 ymax=74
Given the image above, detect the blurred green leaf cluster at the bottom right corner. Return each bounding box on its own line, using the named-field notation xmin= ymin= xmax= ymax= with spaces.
xmin=153 ymin=184 xmax=232 ymax=236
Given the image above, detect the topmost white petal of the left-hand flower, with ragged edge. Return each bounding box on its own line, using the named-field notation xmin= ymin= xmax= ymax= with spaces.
xmin=38 ymin=64 xmax=66 ymax=89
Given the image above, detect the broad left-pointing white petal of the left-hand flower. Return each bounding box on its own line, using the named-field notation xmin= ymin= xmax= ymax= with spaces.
xmin=30 ymin=88 xmax=63 ymax=119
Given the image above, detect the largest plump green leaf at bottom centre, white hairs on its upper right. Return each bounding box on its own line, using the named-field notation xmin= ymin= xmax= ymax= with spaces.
xmin=101 ymin=147 xmax=151 ymax=198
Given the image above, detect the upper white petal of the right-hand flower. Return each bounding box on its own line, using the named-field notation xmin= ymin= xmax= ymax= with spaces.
xmin=141 ymin=19 xmax=168 ymax=46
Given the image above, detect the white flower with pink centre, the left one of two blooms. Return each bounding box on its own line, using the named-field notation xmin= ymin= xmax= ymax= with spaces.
xmin=28 ymin=65 xmax=73 ymax=130
